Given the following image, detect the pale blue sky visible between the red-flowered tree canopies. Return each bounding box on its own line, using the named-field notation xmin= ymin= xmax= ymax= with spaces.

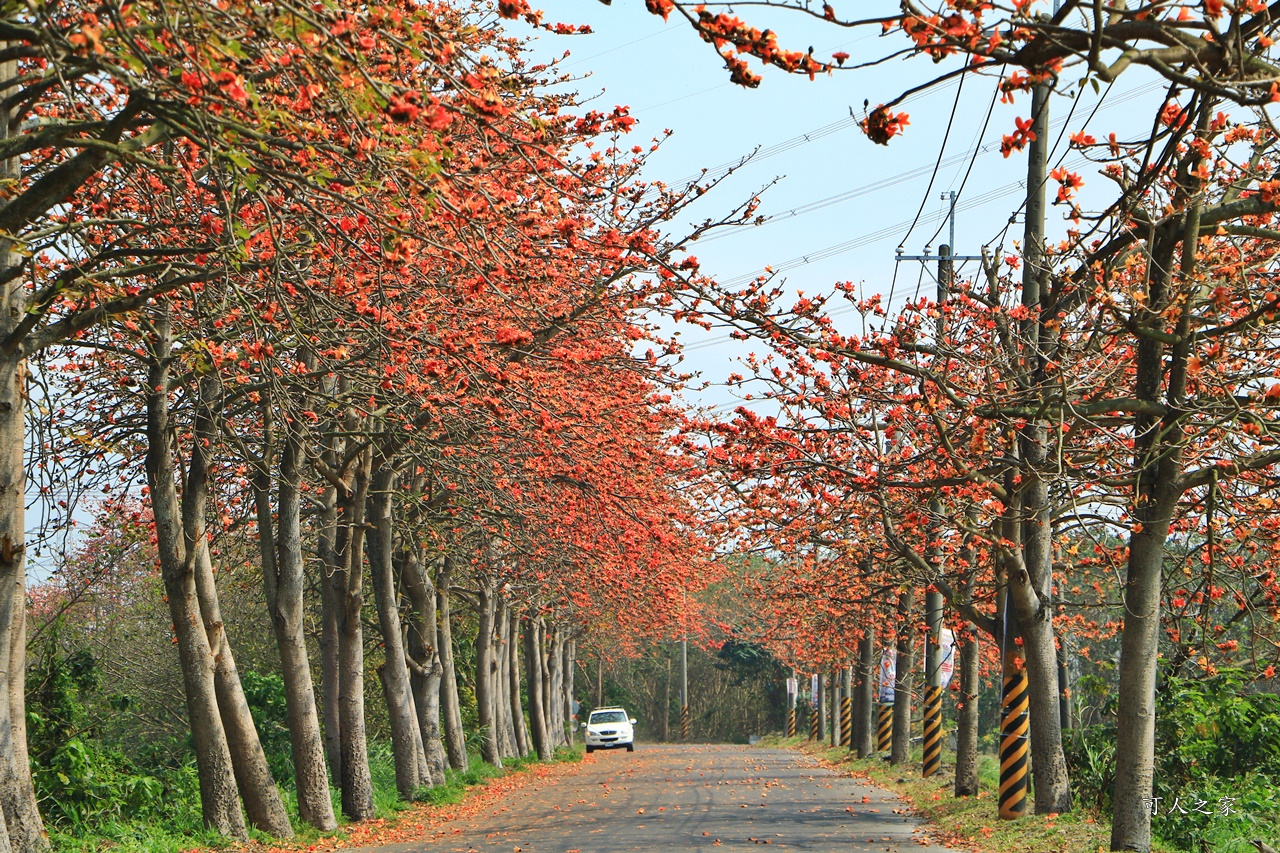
xmin=508 ymin=0 xmax=1164 ymax=405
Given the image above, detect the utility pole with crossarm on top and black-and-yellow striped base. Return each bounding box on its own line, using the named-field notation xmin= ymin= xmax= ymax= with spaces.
xmin=897 ymin=191 xmax=983 ymax=777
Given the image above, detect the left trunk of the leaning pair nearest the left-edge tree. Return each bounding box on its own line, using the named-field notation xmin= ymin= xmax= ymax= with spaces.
xmin=145 ymin=326 xmax=248 ymax=839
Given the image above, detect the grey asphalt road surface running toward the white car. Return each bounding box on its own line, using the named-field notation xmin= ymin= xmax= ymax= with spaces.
xmin=360 ymin=744 xmax=962 ymax=853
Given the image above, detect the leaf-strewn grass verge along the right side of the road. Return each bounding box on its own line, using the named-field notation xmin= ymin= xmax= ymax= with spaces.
xmin=768 ymin=736 xmax=1177 ymax=853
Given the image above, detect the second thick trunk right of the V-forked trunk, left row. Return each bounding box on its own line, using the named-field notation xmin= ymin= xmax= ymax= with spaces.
xmin=369 ymin=459 xmax=431 ymax=802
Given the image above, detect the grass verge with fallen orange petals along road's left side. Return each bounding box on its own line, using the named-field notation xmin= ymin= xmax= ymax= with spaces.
xmin=49 ymin=743 xmax=584 ymax=853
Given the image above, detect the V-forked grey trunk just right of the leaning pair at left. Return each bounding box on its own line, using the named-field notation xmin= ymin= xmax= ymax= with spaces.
xmin=253 ymin=414 xmax=338 ymax=831
